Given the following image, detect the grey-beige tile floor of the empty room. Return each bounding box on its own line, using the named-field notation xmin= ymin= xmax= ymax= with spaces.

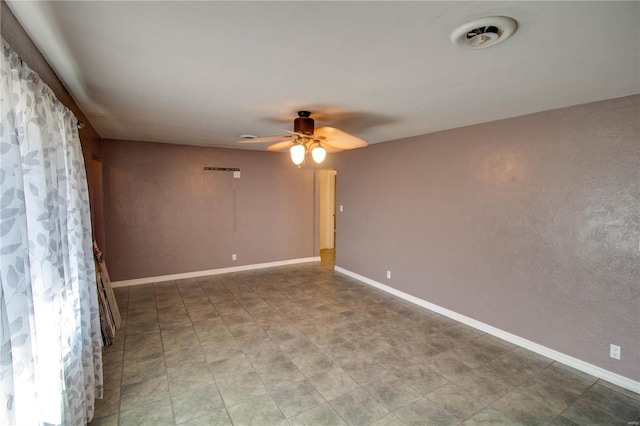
xmin=90 ymin=251 xmax=640 ymax=426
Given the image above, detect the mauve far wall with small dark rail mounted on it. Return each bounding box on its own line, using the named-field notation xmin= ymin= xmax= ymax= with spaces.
xmin=102 ymin=140 xmax=315 ymax=281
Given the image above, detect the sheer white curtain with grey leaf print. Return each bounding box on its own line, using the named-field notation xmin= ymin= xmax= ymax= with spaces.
xmin=0 ymin=40 xmax=102 ymax=425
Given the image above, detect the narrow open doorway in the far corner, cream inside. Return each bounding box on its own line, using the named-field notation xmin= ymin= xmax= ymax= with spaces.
xmin=316 ymin=170 xmax=337 ymax=263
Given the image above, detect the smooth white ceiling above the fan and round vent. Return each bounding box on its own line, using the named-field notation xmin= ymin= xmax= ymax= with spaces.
xmin=7 ymin=0 xmax=640 ymax=149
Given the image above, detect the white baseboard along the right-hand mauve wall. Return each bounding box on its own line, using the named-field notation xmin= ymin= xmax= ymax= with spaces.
xmin=334 ymin=266 xmax=640 ymax=393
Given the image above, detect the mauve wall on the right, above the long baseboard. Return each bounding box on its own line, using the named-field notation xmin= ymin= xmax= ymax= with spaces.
xmin=337 ymin=96 xmax=640 ymax=380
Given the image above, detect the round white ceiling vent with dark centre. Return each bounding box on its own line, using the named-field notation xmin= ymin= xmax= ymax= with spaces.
xmin=451 ymin=16 xmax=518 ymax=49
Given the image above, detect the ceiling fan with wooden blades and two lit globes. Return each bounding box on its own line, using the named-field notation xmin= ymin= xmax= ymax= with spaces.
xmin=238 ymin=111 xmax=369 ymax=167
